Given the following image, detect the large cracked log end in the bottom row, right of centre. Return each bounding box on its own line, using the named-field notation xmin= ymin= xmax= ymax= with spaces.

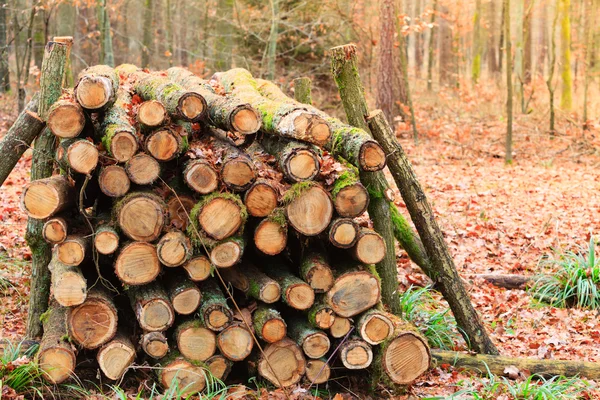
xmin=258 ymin=338 xmax=306 ymax=387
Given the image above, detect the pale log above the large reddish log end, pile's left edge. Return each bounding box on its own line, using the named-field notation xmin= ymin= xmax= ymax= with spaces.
xmin=48 ymin=256 xmax=87 ymax=307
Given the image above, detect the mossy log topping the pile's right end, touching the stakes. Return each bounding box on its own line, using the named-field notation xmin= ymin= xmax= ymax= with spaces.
xmin=257 ymin=79 xmax=386 ymax=172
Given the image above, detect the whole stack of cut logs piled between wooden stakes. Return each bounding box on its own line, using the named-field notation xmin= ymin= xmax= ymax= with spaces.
xmin=22 ymin=65 xmax=430 ymax=393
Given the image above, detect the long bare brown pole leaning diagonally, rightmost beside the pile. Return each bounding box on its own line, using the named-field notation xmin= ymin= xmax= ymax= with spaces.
xmin=369 ymin=110 xmax=498 ymax=354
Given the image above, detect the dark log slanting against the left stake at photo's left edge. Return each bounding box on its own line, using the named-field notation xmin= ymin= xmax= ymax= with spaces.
xmin=0 ymin=93 xmax=44 ymax=187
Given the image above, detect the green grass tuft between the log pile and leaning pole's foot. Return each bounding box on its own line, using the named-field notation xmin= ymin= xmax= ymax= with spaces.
xmin=400 ymin=286 xmax=461 ymax=350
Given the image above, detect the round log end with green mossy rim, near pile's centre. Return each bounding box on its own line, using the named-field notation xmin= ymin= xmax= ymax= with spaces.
xmin=198 ymin=197 xmax=244 ymax=240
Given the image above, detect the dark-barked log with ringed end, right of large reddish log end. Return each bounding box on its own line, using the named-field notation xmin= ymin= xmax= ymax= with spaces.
xmin=127 ymin=282 xmax=175 ymax=332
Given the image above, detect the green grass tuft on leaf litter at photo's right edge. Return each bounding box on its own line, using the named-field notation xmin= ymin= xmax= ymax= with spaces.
xmin=529 ymin=236 xmax=600 ymax=309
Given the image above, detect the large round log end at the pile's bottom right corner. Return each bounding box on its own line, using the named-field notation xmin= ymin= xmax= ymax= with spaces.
xmin=382 ymin=332 xmax=431 ymax=385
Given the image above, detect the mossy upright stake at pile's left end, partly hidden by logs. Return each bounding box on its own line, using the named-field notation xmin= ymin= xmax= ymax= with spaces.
xmin=25 ymin=42 xmax=67 ymax=338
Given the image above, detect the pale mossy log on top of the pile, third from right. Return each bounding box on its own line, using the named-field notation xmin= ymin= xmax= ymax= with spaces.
xmin=167 ymin=67 xmax=261 ymax=135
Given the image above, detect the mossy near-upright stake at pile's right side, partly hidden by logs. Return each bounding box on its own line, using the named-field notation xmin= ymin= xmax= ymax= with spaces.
xmin=331 ymin=45 xmax=400 ymax=314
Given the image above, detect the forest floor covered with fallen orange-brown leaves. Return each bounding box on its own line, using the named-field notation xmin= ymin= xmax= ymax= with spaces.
xmin=0 ymin=84 xmax=600 ymax=399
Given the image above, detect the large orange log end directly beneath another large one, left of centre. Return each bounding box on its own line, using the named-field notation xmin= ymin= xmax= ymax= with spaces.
xmin=115 ymin=242 xmax=160 ymax=285
